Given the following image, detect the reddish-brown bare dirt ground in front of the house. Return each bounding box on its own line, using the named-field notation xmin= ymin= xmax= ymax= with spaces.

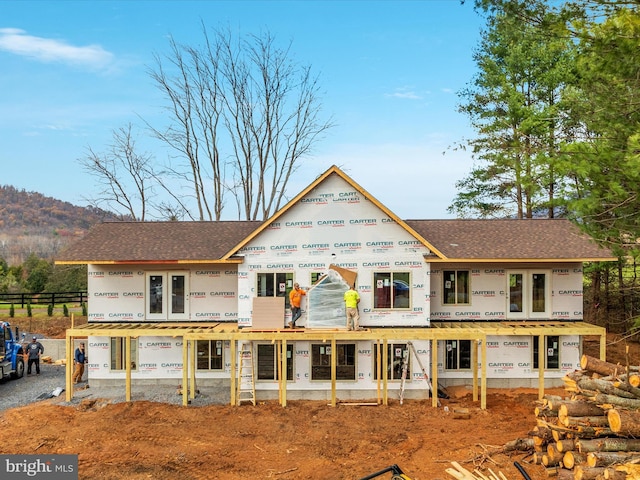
xmin=0 ymin=320 xmax=640 ymax=480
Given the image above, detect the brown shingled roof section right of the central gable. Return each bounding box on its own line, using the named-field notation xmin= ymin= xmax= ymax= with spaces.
xmin=406 ymin=219 xmax=617 ymax=262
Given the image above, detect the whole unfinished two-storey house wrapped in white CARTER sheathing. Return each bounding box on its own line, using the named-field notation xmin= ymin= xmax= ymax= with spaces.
xmin=56 ymin=167 xmax=615 ymax=403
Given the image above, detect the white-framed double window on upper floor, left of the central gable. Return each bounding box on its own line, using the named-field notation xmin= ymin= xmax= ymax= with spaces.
xmin=147 ymin=272 xmax=189 ymax=320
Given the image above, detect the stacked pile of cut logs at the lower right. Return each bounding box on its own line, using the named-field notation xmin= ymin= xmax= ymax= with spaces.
xmin=530 ymin=355 xmax=640 ymax=480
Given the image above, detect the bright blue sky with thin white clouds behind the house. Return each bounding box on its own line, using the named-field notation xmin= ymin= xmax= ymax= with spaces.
xmin=0 ymin=0 xmax=483 ymax=219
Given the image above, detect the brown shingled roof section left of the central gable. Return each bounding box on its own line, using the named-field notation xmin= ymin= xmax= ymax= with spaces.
xmin=56 ymin=221 xmax=262 ymax=264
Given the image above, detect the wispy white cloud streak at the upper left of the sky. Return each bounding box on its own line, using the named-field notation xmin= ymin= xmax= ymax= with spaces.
xmin=0 ymin=28 xmax=113 ymax=68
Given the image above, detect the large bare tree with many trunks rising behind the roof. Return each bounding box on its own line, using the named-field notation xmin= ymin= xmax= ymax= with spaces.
xmin=147 ymin=25 xmax=331 ymax=220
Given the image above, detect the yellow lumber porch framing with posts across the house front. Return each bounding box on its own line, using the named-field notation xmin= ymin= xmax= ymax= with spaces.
xmin=65 ymin=321 xmax=606 ymax=409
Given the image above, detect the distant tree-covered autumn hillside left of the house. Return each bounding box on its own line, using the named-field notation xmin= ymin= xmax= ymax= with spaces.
xmin=0 ymin=185 xmax=120 ymax=265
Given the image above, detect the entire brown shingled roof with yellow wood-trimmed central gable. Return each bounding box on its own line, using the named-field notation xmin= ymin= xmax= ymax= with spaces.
xmin=56 ymin=166 xmax=617 ymax=264
